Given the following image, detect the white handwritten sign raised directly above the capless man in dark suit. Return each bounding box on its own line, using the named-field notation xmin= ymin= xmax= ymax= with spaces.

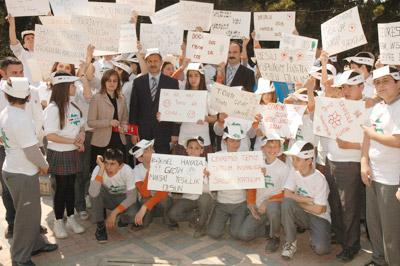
xmin=211 ymin=10 xmax=251 ymax=39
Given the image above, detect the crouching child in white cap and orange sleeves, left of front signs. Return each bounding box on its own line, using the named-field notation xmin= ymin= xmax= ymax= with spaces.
xmin=129 ymin=139 xmax=177 ymax=231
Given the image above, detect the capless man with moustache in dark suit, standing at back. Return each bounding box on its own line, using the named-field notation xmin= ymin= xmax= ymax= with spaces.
xmin=225 ymin=42 xmax=255 ymax=92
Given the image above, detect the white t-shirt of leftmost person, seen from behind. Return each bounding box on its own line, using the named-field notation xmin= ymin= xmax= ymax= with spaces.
xmin=0 ymin=106 xmax=38 ymax=176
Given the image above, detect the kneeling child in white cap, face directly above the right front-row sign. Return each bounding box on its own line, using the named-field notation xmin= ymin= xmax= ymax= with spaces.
xmin=207 ymin=125 xmax=247 ymax=239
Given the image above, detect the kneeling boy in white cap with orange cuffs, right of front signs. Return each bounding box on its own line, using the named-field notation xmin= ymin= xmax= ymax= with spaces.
xmin=239 ymin=133 xmax=289 ymax=253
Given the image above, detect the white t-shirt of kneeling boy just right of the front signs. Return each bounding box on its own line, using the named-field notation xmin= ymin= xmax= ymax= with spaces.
xmin=256 ymin=159 xmax=289 ymax=207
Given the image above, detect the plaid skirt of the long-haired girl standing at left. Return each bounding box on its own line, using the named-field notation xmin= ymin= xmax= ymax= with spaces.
xmin=46 ymin=150 xmax=82 ymax=175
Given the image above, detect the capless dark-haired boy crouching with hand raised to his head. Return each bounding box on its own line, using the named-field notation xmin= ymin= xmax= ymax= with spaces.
xmin=89 ymin=148 xmax=137 ymax=243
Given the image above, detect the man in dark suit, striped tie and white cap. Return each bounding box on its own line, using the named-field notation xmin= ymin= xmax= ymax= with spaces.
xmin=129 ymin=49 xmax=179 ymax=154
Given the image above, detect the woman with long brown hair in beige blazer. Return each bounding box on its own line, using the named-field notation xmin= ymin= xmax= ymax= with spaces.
xmin=88 ymin=69 xmax=128 ymax=171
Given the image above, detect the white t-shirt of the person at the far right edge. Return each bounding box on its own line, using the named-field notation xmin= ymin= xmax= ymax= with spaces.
xmin=369 ymin=100 xmax=400 ymax=185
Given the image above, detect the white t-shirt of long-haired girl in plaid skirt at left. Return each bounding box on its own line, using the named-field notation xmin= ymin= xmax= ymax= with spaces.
xmin=44 ymin=102 xmax=84 ymax=151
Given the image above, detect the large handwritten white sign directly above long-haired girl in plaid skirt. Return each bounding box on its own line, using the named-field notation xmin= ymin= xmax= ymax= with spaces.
xmin=35 ymin=24 xmax=89 ymax=64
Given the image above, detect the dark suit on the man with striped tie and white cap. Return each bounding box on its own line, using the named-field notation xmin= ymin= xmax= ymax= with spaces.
xmin=129 ymin=74 xmax=180 ymax=153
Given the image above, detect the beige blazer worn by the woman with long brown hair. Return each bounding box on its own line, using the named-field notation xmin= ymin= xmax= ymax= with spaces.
xmin=87 ymin=93 xmax=128 ymax=147
